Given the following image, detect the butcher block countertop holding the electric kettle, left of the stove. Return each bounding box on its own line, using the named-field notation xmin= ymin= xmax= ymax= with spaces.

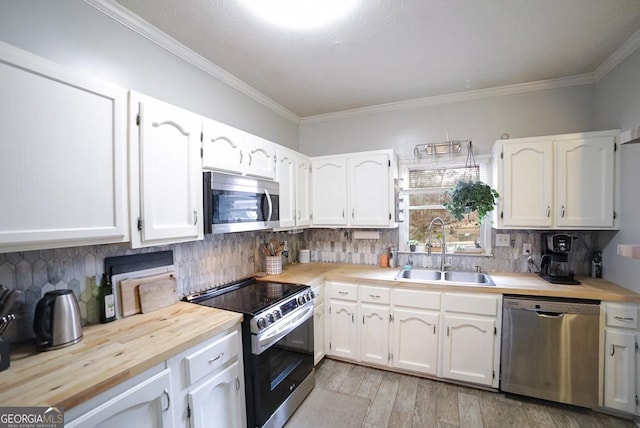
xmin=0 ymin=302 xmax=242 ymax=410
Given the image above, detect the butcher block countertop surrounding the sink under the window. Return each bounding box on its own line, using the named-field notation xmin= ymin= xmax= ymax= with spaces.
xmin=260 ymin=263 xmax=640 ymax=303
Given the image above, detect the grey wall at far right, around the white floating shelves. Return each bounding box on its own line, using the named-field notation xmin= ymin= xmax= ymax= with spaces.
xmin=595 ymin=50 xmax=640 ymax=293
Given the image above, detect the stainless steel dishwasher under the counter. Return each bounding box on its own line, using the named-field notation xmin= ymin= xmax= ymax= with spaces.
xmin=500 ymin=296 xmax=600 ymax=408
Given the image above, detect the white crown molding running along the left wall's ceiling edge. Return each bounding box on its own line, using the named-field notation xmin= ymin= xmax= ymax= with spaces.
xmin=83 ymin=0 xmax=300 ymax=125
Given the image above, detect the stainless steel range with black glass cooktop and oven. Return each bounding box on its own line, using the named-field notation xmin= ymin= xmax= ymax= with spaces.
xmin=185 ymin=278 xmax=315 ymax=428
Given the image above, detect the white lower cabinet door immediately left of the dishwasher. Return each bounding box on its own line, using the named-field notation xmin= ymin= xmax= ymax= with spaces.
xmin=440 ymin=315 xmax=496 ymax=385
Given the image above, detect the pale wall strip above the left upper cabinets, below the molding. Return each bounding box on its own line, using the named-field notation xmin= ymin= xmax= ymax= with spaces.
xmin=0 ymin=0 xmax=298 ymax=149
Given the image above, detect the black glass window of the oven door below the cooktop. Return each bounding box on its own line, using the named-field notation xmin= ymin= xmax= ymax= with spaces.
xmin=251 ymin=317 xmax=313 ymax=426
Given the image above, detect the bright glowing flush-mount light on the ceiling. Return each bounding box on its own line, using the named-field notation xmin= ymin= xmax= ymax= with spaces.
xmin=241 ymin=0 xmax=360 ymax=29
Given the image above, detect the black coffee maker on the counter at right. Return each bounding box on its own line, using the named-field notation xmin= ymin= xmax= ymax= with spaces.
xmin=539 ymin=233 xmax=580 ymax=285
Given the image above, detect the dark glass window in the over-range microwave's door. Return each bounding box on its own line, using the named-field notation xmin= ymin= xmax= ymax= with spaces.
xmin=213 ymin=189 xmax=264 ymax=224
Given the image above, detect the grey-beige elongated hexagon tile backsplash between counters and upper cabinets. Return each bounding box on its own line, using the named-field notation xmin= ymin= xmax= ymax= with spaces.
xmin=0 ymin=229 xmax=598 ymax=341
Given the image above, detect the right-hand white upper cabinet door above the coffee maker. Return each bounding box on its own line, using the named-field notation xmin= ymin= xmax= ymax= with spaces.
xmin=555 ymin=137 xmax=615 ymax=227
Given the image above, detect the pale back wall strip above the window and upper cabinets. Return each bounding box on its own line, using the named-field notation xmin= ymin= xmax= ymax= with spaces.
xmin=300 ymin=85 xmax=596 ymax=156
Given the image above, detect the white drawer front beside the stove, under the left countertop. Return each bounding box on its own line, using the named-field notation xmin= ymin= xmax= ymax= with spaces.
xmin=185 ymin=329 xmax=242 ymax=385
